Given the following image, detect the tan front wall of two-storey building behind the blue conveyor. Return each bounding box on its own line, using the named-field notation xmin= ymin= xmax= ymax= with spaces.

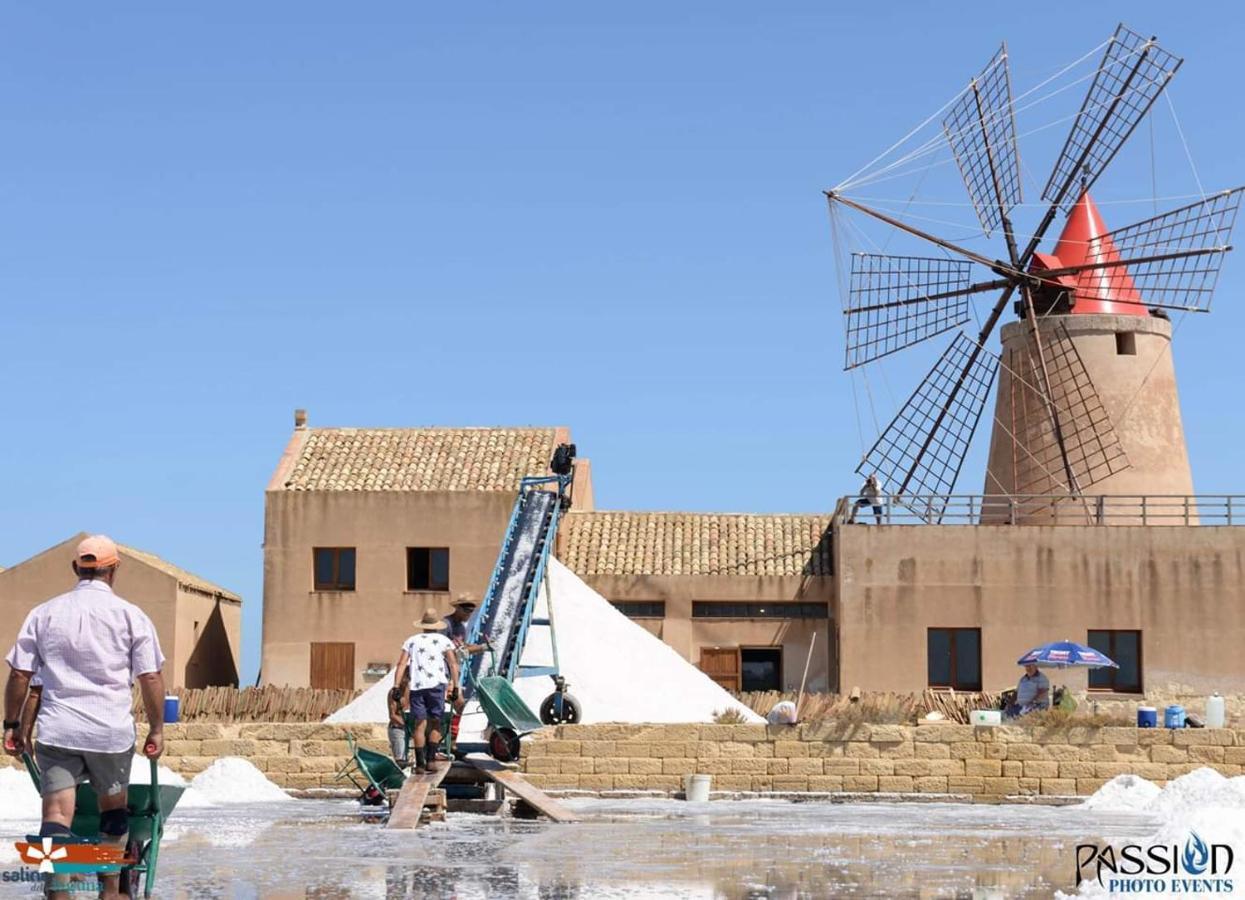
xmin=260 ymin=490 xmax=515 ymax=687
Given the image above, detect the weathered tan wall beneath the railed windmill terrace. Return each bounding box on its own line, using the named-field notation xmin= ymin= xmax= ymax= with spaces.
xmin=834 ymin=525 xmax=1245 ymax=692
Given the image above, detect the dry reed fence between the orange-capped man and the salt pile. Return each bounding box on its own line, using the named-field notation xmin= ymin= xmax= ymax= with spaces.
xmin=132 ymin=687 xmax=361 ymax=722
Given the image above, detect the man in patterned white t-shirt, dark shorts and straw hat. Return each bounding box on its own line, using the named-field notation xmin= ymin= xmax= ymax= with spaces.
xmin=393 ymin=610 xmax=458 ymax=773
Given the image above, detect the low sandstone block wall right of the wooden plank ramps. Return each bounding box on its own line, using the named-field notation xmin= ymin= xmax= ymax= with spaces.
xmin=523 ymin=723 xmax=1245 ymax=800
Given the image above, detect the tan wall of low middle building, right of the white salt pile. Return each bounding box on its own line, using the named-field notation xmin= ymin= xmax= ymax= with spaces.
xmin=580 ymin=575 xmax=837 ymax=691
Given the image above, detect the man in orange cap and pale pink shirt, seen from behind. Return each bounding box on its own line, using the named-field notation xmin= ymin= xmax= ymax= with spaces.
xmin=4 ymin=534 xmax=164 ymax=896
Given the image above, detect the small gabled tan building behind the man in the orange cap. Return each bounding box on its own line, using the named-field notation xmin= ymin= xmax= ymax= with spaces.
xmin=0 ymin=533 xmax=242 ymax=687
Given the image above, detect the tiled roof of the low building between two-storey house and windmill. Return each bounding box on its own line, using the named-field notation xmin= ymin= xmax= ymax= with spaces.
xmin=561 ymin=512 xmax=832 ymax=575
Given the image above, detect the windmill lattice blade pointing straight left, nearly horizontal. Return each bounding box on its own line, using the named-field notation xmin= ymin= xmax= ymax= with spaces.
xmin=843 ymin=253 xmax=972 ymax=368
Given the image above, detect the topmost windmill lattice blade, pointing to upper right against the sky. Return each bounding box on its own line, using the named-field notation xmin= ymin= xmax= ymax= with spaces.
xmin=1042 ymin=25 xmax=1183 ymax=212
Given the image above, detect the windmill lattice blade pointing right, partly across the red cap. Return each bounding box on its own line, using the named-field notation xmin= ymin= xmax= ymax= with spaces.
xmin=1077 ymin=188 xmax=1243 ymax=312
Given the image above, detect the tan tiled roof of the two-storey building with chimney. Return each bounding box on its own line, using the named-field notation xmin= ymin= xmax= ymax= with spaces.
xmin=284 ymin=428 xmax=557 ymax=490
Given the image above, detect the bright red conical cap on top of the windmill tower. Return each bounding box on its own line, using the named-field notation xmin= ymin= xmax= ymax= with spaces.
xmin=1055 ymin=192 xmax=1149 ymax=316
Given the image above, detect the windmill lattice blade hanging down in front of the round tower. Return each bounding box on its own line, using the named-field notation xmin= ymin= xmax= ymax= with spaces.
xmin=1005 ymin=322 xmax=1129 ymax=494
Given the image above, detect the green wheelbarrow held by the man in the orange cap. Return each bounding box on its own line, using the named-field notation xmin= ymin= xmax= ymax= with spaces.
xmin=20 ymin=753 xmax=186 ymax=898
